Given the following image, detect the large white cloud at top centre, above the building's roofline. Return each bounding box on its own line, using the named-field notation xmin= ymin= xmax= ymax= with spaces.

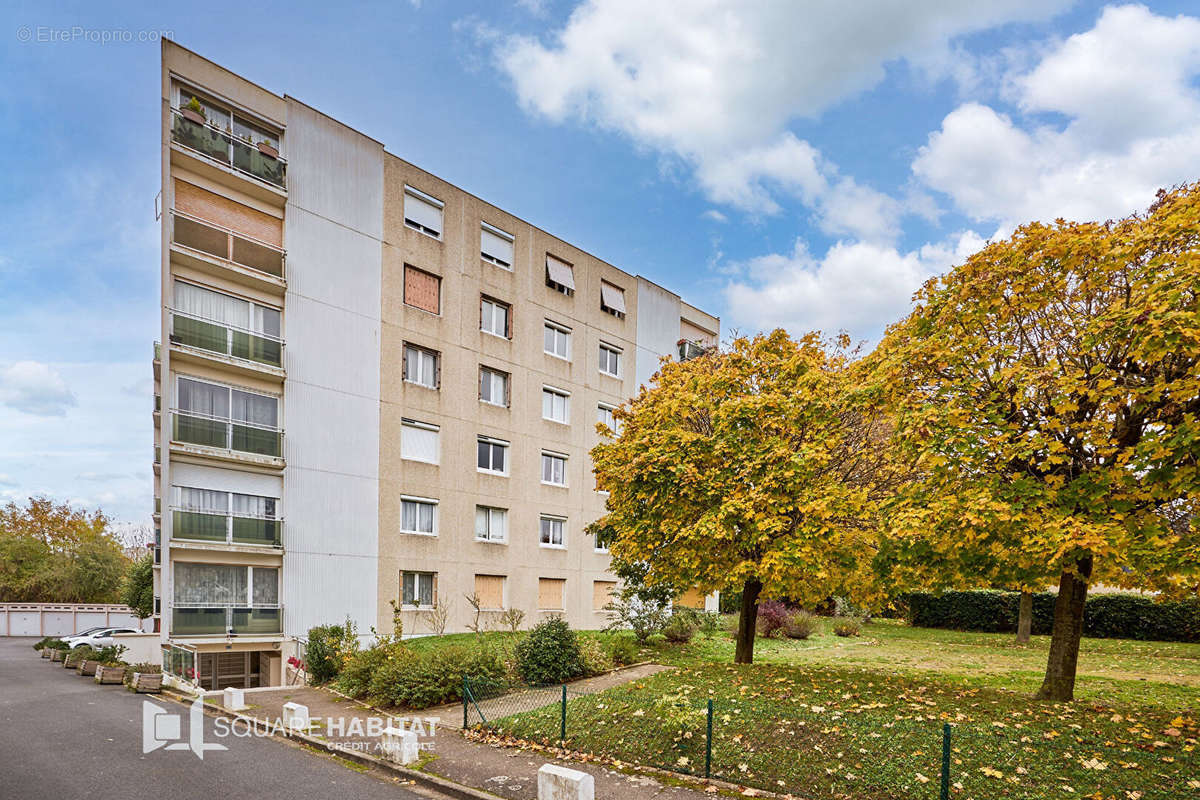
xmin=496 ymin=0 xmax=1069 ymax=219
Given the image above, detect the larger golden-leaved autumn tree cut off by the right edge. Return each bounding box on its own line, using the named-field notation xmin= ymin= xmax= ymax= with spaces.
xmin=877 ymin=185 xmax=1200 ymax=700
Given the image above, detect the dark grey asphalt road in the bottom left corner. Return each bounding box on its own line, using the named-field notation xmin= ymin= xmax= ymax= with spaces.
xmin=0 ymin=637 xmax=439 ymax=800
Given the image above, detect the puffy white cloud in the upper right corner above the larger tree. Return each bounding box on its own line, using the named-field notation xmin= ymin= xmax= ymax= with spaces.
xmin=913 ymin=6 xmax=1200 ymax=228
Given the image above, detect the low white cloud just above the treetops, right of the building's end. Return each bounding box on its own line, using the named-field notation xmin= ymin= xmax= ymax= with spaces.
xmin=725 ymin=230 xmax=984 ymax=339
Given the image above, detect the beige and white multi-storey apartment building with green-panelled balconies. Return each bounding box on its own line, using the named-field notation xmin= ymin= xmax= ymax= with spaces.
xmin=154 ymin=42 xmax=720 ymax=688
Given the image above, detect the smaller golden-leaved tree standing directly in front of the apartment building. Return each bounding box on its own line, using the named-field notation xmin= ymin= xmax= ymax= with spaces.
xmin=592 ymin=330 xmax=902 ymax=663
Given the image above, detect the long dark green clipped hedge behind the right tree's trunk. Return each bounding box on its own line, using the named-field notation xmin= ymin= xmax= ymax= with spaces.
xmin=899 ymin=590 xmax=1200 ymax=642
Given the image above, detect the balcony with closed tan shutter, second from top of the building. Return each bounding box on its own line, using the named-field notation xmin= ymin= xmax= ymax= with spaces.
xmin=170 ymin=211 xmax=287 ymax=289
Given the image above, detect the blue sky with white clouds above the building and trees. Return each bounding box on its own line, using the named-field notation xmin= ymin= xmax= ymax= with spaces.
xmin=0 ymin=0 xmax=1200 ymax=524
